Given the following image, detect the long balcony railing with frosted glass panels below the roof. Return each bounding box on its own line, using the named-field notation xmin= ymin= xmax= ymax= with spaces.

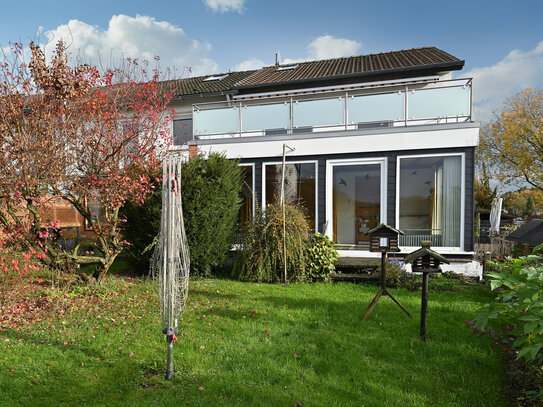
xmin=193 ymin=79 xmax=472 ymax=139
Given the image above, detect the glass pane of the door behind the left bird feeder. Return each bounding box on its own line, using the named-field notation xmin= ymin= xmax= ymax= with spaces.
xmin=332 ymin=164 xmax=381 ymax=247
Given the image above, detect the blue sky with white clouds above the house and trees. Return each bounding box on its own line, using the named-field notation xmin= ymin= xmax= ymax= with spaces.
xmin=0 ymin=0 xmax=543 ymax=122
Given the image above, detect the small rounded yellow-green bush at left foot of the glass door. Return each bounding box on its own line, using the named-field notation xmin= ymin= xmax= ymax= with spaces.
xmin=305 ymin=233 xmax=338 ymax=281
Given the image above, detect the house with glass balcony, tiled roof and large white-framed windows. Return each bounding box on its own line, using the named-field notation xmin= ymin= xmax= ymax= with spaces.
xmin=170 ymin=47 xmax=480 ymax=274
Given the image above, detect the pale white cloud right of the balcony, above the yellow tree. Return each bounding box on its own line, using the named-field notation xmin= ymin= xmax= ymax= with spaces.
xmin=462 ymin=41 xmax=543 ymax=122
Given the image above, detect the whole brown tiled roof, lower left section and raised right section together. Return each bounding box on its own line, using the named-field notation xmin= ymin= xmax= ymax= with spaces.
xmin=161 ymin=47 xmax=464 ymax=97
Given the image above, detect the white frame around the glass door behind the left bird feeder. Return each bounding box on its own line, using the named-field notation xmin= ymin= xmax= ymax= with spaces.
xmin=324 ymin=157 xmax=388 ymax=252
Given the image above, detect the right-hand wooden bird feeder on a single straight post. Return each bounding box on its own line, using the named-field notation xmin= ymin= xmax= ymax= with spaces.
xmin=405 ymin=240 xmax=450 ymax=341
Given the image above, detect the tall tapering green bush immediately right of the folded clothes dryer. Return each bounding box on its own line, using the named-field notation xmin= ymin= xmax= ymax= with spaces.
xmin=181 ymin=153 xmax=242 ymax=277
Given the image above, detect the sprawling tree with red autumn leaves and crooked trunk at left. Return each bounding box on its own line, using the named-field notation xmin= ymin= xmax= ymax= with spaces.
xmin=0 ymin=42 xmax=171 ymax=283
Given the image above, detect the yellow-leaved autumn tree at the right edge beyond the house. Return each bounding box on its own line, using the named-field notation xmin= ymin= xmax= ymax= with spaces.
xmin=477 ymin=89 xmax=543 ymax=191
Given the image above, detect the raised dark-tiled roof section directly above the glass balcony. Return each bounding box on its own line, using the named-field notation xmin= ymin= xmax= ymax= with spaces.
xmin=235 ymin=47 xmax=464 ymax=88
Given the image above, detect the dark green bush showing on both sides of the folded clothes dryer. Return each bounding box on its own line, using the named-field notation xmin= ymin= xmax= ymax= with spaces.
xmin=123 ymin=153 xmax=241 ymax=276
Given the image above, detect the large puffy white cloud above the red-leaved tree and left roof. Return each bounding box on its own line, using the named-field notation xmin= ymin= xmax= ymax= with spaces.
xmin=41 ymin=14 xmax=219 ymax=76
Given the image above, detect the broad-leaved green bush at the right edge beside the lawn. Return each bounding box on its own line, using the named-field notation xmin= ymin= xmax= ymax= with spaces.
xmin=474 ymin=245 xmax=543 ymax=366
